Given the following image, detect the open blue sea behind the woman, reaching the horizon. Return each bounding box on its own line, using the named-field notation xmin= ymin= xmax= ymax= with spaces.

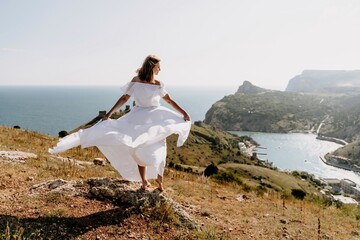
xmin=0 ymin=86 xmax=237 ymax=136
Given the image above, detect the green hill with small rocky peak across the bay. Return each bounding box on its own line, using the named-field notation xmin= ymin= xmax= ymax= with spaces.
xmin=204 ymin=81 xmax=360 ymax=164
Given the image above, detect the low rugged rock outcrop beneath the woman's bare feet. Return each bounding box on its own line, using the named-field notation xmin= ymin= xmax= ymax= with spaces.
xmin=29 ymin=178 xmax=198 ymax=228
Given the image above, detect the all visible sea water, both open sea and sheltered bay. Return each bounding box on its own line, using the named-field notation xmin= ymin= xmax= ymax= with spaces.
xmin=0 ymin=86 xmax=360 ymax=185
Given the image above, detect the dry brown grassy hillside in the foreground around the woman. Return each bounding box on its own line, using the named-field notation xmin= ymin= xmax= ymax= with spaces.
xmin=0 ymin=126 xmax=360 ymax=240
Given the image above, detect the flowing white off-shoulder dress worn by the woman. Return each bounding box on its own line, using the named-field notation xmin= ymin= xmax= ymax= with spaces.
xmin=49 ymin=82 xmax=191 ymax=181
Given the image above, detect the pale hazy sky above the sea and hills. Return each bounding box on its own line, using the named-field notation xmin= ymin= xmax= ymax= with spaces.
xmin=0 ymin=0 xmax=360 ymax=90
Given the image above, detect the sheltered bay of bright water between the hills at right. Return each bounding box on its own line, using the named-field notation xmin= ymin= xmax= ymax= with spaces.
xmin=233 ymin=131 xmax=360 ymax=185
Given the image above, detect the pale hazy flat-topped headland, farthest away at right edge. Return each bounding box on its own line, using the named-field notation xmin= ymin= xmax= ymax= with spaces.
xmin=286 ymin=70 xmax=360 ymax=93
